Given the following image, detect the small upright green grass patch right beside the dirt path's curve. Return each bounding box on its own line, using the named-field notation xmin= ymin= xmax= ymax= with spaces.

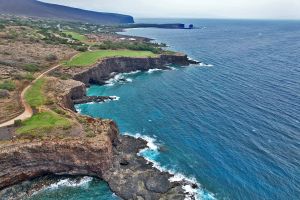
xmin=25 ymin=79 xmax=46 ymax=108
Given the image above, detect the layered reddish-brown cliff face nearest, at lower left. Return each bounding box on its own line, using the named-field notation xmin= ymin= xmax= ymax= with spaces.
xmin=0 ymin=120 xmax=118 ymax=189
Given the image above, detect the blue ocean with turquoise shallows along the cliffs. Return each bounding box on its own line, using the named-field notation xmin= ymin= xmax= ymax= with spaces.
xmin=32 ymin=19 xmax=300 ymax=200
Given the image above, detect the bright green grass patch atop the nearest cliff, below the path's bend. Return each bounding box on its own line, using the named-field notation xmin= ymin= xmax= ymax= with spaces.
xmin=17 ymin=111 xmax=72 ymax=136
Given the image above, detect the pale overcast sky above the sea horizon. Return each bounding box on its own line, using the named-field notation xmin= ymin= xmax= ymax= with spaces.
xmin=40 ymin=0 xmax=300 ymax=19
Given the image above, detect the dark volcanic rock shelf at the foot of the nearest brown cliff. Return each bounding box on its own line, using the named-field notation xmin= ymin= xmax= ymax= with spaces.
xmin=104 ymin=136 xmax=185 ymax=200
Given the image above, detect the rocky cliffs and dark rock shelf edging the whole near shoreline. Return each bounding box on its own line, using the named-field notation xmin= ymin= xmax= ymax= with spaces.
xmin=0 ymin=54 xmax=197 ymax=200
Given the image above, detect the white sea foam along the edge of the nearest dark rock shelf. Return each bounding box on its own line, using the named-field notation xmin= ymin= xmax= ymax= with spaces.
xmin=123 ymin=132 xmax=215 ymax=200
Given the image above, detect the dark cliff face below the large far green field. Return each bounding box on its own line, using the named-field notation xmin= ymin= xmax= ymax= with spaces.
xmin=63 ymin=53 xmax=192 ymax=85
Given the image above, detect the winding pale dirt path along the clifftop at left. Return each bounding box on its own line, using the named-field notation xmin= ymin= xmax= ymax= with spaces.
xmin=0 ymin=65 xmax=60 ymax=127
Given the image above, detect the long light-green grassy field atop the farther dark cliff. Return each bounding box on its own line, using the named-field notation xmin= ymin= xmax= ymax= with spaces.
xmin=65 ymin=50 xmax=158 ymax=67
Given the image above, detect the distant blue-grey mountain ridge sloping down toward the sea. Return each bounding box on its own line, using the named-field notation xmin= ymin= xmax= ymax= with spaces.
xmin=0 ymin=0 xmax=134 ymax=24
